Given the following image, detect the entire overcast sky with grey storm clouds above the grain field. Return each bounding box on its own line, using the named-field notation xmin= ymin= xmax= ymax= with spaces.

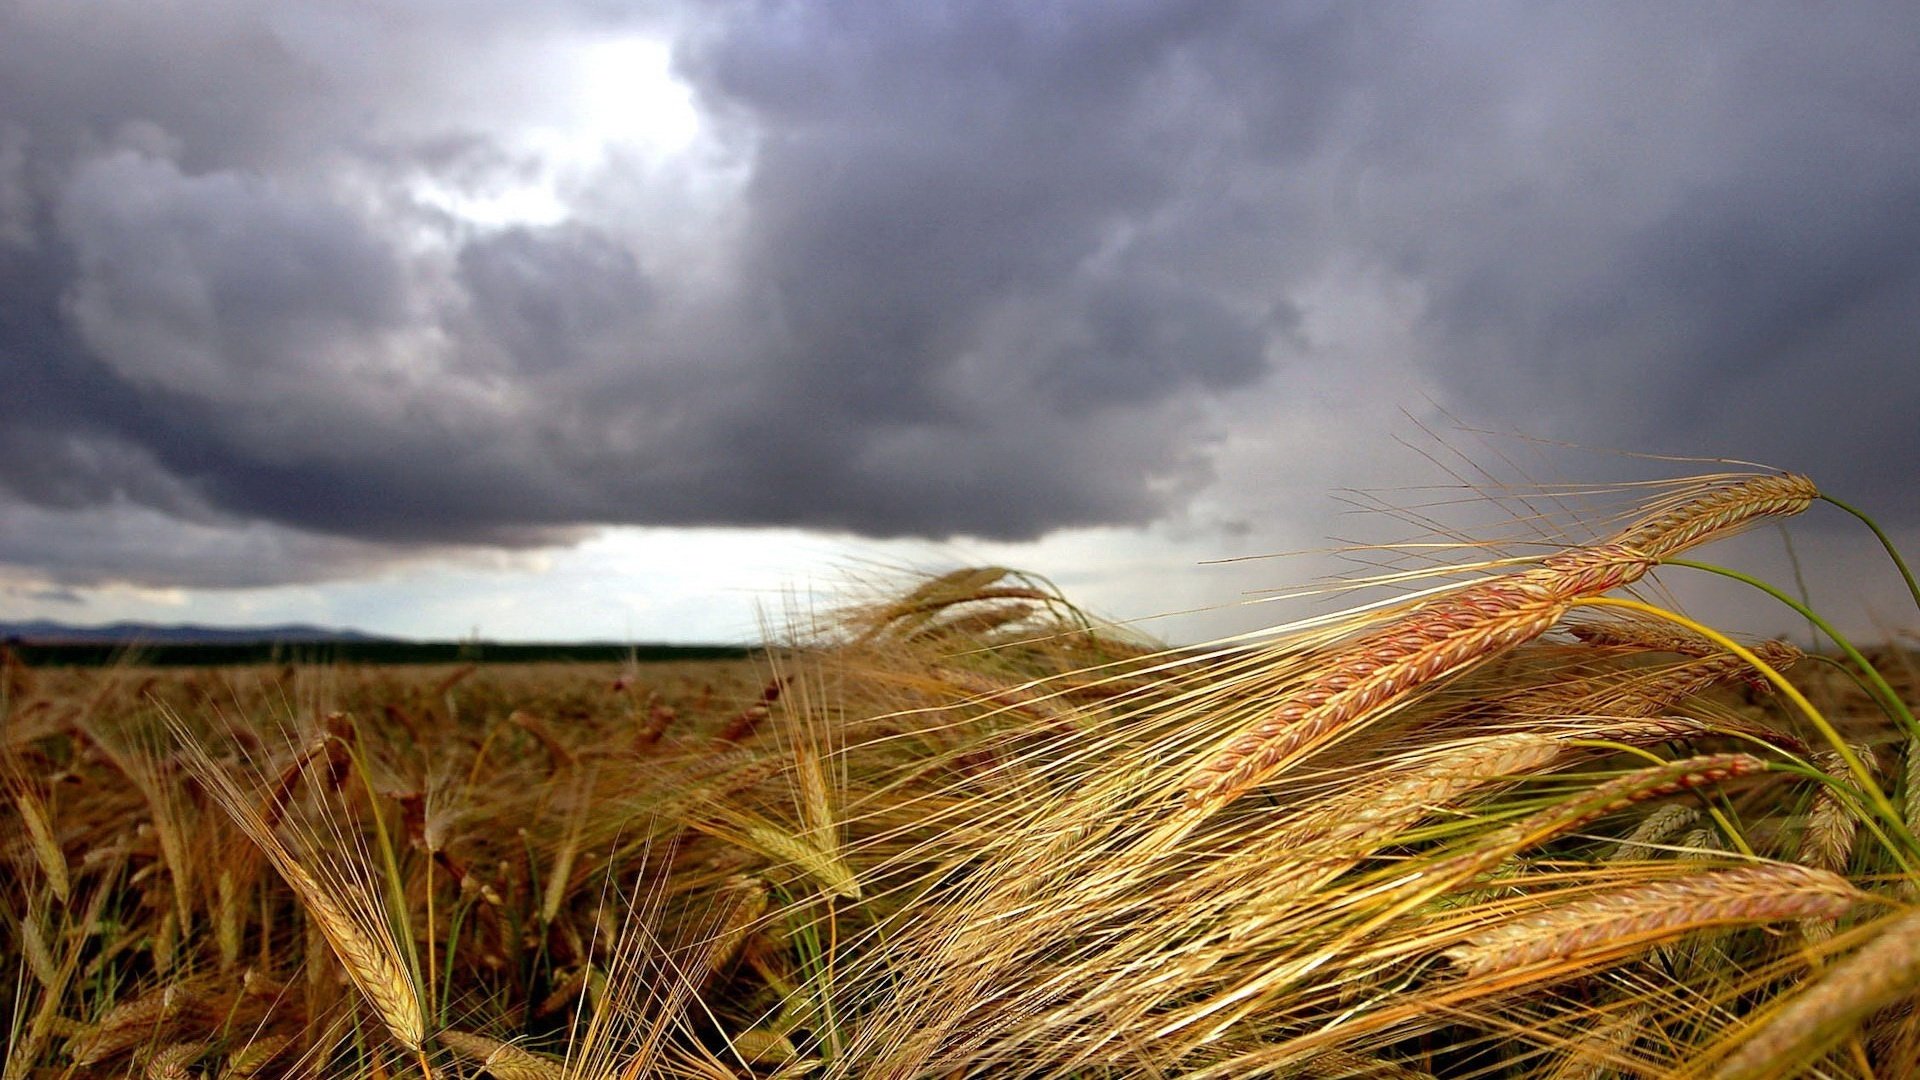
xmin=0 ymin=0 xmax=1920 ymax=640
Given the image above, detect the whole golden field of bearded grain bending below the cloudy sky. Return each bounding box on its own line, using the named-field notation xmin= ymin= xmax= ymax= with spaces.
xmin=0 ymin=473 xmax=1920 ymax=1080
